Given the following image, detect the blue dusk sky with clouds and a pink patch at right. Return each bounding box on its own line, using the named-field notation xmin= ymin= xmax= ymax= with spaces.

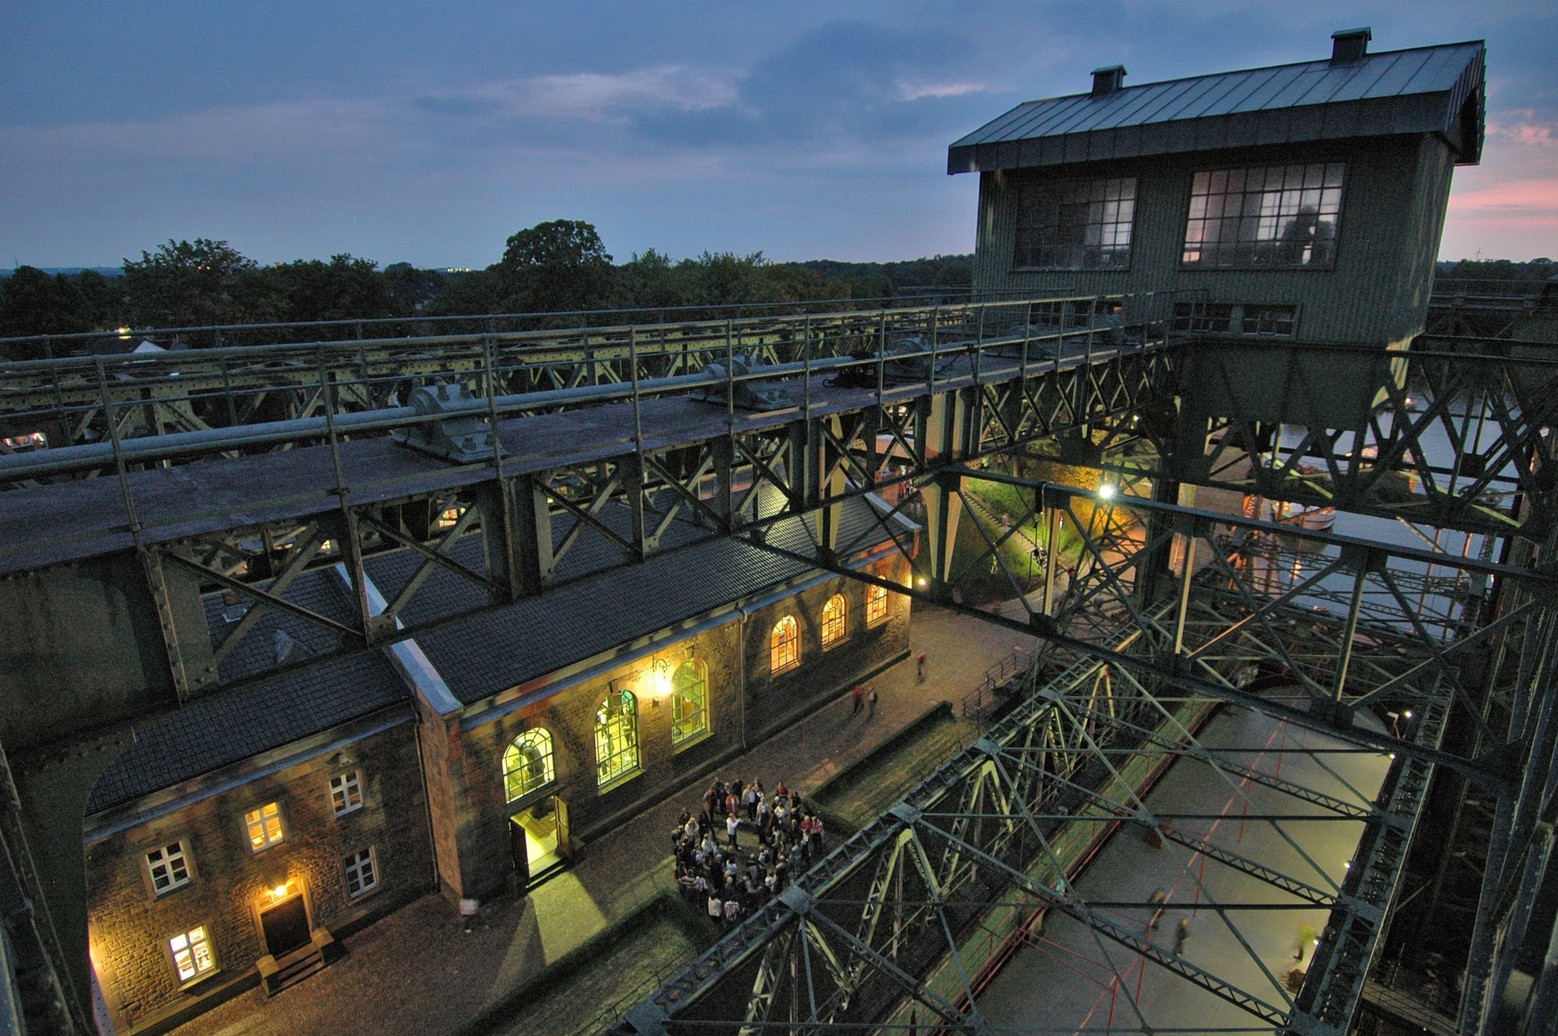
xmin=0 ymin=0 xmax=1558 ymax=266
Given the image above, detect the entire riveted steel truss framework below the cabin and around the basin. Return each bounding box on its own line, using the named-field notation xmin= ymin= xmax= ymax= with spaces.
xmin=0 ymin=298 xmax=1558 ymax=1033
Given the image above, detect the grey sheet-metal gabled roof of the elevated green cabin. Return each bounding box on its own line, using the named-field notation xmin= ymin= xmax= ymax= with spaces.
xmin=947 ymin=41 xmax=1485 ymax=173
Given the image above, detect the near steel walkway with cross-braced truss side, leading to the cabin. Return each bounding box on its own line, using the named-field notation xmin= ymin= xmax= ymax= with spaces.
xmin=0 ymin=299 xmax=1173 ymax=704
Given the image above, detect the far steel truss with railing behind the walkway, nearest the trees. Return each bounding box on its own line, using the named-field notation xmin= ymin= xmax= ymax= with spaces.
xmin=0 ymin=296 xmax=1152 ymax=452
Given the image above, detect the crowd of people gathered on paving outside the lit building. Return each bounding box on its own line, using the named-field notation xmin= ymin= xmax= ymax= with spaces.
xmin=671 ymin=777 xmax=823 ymax=925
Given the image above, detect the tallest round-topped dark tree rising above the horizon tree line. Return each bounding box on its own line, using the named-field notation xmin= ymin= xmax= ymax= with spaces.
xmin=495 ymin=220 xmax=615 ymax=313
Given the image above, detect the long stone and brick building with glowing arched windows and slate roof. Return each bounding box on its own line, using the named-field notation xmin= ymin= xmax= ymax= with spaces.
xmin=86 ymin=500 xmax=913 ymax=1033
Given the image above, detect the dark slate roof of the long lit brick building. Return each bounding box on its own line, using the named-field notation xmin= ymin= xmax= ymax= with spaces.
xmin=87 ymin=499 xmax=909 ymax=815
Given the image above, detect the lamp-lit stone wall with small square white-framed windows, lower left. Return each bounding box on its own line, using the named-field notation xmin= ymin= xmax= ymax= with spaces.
xmin=86 ymin=721 xmax=433 ymax=1031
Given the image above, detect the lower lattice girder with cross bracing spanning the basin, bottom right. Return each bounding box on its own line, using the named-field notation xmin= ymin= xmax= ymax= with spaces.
xmin=619 ymin=610 xmax=1424 ymax=1033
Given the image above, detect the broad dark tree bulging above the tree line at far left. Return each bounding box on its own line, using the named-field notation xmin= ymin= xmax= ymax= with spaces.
xmin=125 ymin=237 xmax=256 ymax=327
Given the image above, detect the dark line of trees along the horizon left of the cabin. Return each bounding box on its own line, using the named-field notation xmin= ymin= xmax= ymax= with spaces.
xmin=0 ymin=220 xmax=972 ymax=358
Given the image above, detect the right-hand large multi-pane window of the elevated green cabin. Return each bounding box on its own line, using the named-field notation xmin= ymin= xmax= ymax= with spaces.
xmin=1179 ymin=162 xmax=1346 ymax=270
